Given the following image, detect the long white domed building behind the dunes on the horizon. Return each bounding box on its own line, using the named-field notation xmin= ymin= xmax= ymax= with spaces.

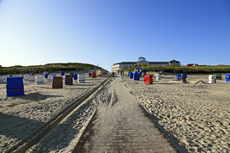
xmin=112 ymin=56 xmax=180 ymax=72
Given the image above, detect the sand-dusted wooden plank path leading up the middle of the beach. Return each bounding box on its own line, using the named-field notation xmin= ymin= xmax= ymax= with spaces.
xmin=73 ymin=77 xmax=178 ymax=153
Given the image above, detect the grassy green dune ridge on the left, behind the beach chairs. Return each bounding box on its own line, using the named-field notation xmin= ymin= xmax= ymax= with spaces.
xmin=0 ymin=63 xmax=104 ymax=75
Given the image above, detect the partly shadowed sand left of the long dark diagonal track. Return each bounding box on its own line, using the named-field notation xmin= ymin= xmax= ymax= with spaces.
xmin=0 ymin=73 xmax=109 ymax=152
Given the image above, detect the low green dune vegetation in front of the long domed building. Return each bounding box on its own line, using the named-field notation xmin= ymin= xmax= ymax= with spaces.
xmin=124 ymin=65 xmax=230 ymax=74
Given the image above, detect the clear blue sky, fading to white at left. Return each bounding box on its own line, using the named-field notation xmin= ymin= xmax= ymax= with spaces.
xmin=0 ymin=0 xmax=230 ymax=71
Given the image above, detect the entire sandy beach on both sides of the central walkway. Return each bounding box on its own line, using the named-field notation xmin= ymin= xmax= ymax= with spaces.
xmin=0 ymin=74 xmax=230 ymax=153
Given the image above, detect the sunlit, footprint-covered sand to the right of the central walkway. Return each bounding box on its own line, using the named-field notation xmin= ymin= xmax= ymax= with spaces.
xmin=123 ymin=74 xmax=230 ymax=152
